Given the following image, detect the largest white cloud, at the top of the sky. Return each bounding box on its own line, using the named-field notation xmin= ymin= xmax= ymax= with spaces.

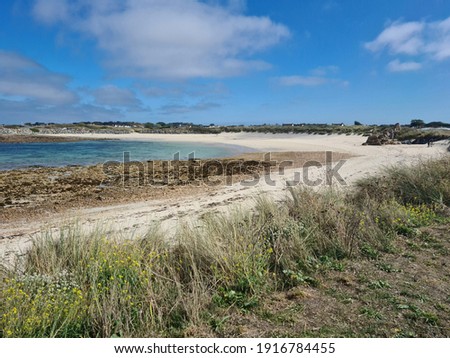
xmin=33 ymin=0 xmax=290 ymax=80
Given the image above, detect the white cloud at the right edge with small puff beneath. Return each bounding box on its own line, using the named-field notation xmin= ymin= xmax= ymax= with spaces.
xmin=364 ymin=17 xmax=450 ymax=65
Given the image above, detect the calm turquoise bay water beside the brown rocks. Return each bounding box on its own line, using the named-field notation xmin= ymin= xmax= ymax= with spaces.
xmin=0 ymin=140 xmax=247 ymax=170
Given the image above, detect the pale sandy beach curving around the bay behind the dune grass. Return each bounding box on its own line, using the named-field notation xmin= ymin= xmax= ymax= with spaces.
xmin=0 ymin=133 xmax=448 ymax=259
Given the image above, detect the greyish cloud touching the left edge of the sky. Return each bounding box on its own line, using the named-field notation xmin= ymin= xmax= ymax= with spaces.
xmin=0 ymin=50 xmax=78 ymax=105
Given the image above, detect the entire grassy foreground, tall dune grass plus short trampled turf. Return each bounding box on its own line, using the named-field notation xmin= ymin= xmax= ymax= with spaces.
xmin=0 ymin=157 xmax=450 ymax=337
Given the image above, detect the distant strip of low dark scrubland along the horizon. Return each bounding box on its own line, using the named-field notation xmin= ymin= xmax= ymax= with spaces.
xmin=0 ymin=120 xmax=450 ymax=144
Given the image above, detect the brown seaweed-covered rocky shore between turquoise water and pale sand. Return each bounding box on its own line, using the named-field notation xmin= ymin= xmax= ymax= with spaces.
xmin=0 ymin=152 xmax=350 ymax=222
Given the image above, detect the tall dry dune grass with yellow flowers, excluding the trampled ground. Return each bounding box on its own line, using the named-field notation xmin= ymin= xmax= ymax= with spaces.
xmin=0 ymin=157 xmax=450 ymax=337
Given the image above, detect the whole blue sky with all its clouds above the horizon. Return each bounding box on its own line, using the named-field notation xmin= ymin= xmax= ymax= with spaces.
xmin=0 ymin=0 xmax=450 ymax=124
